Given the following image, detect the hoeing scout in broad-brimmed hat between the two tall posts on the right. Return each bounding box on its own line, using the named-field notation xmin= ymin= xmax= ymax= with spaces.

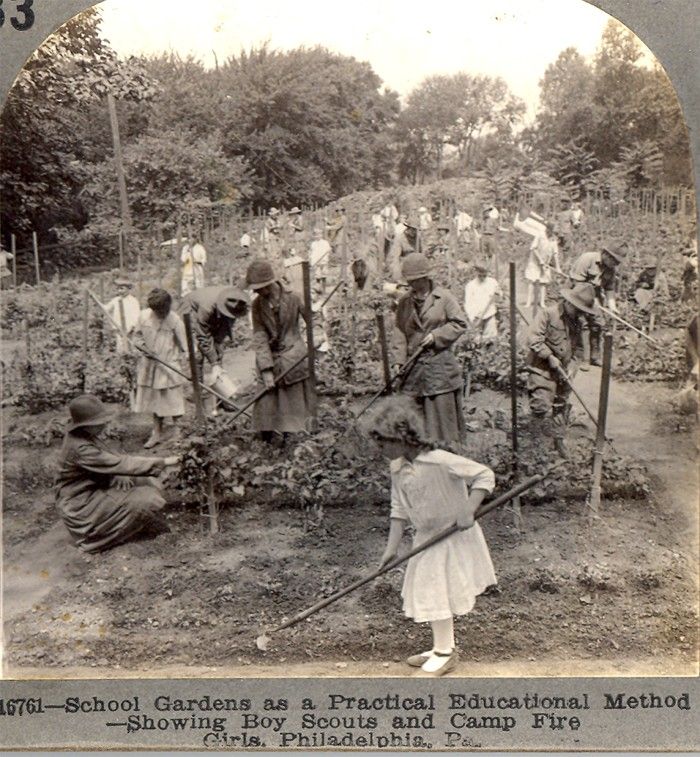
xmin=527 ymin=284 xmax=596 ymax=457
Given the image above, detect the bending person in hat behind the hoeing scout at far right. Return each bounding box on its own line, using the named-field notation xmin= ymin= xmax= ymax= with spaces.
xmin=569 ymin=245 xmax=624 ymax=370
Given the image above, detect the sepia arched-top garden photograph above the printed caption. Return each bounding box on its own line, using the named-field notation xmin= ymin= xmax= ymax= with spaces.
xmin=0 ymin=0 xmax=699 ymax=692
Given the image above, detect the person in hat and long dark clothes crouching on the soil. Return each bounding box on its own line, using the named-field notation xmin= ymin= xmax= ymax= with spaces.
xmin=56 ymin=394 xmax=179 ymax=552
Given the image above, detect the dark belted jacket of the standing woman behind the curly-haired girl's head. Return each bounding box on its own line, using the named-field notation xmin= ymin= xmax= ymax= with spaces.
xmin=396 ymin=287 xmax=467 ymax=397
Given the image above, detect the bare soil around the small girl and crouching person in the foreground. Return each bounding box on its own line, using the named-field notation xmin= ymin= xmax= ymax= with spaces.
xmin=3 ymin=358 xmax=698 ymax=678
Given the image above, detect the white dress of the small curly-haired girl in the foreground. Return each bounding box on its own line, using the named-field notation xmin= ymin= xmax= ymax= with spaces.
xmin=391 ymin=450 xmax=496 ymax=623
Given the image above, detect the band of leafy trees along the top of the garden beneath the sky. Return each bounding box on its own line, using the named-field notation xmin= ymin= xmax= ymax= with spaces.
xmin=0 ymin=9 xmax=691 ymax=260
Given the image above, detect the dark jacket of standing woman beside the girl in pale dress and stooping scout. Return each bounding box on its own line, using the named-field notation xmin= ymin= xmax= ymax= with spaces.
xmin=252 ymin=287 xmax=309 ymax=386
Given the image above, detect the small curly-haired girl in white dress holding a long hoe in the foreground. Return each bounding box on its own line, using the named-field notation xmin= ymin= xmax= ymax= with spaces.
xmin=369 ymin=397 xmax=496 ymax=676
